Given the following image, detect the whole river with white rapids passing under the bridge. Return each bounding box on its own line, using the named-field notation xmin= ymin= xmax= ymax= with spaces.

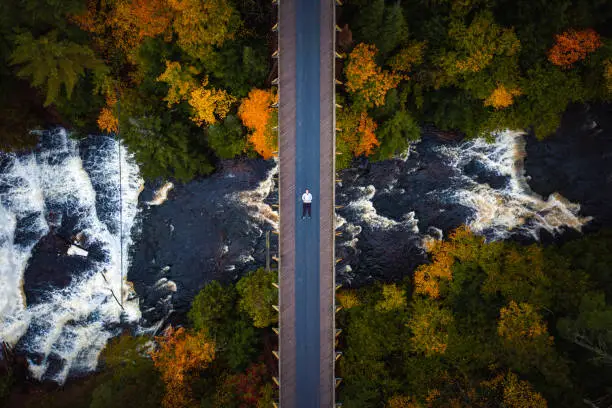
xmin=0 ymin=102 xmax=612 ymax=383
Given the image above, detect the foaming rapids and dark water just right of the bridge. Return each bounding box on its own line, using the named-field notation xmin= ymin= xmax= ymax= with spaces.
xmin=336 ymin=131 xmax=591 ymax=283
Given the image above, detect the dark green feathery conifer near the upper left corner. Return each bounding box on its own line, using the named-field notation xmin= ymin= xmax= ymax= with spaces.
xmin=11 ymin=31 xmax=105 ymax=106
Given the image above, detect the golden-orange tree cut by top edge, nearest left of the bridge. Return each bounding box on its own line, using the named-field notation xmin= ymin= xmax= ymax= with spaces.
xmin=168 ymin=0 xmax=241 ymax=59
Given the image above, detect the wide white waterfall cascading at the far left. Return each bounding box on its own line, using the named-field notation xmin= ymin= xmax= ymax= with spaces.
xmin=0 ymin=129 xmax=142 ymax=383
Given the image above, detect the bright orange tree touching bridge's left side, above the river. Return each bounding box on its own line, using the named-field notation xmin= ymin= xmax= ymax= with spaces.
xmin=238 ymin=89 xmax=277 ymax=159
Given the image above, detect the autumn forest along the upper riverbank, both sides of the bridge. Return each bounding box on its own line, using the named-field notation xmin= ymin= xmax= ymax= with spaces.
xmin=0 ymin=0 xmax=612 ymax=176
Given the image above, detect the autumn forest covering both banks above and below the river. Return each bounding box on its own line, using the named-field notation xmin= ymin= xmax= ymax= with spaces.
xmin=0 ymin=0 xmax=612 ymax=408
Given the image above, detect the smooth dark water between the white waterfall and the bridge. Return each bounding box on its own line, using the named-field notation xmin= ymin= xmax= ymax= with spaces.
xmin=134 ymin=160 xmax=277 ymax=322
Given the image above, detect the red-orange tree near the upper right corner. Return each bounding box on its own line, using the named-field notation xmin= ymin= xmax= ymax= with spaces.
xmin=548 ymin=28 xmax=602 ymax=68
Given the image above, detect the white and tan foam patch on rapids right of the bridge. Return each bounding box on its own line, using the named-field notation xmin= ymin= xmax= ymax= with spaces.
xmin=439 ymin=131 xmax=591 ymax=239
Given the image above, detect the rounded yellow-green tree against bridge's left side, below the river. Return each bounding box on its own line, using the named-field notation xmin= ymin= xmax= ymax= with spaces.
xmin=236 ymin=268 xmax=278 ymax=327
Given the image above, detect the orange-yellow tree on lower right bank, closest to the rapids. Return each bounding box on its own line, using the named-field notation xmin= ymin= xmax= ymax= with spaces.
xmin=414 ymin=226 xmax=484 ymax=299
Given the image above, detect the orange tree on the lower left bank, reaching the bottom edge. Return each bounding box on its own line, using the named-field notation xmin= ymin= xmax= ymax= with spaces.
xmin=151 ymin=326 xmax=215 ymax=408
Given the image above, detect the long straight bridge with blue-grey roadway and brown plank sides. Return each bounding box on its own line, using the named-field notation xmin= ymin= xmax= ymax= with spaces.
xmin=275 ymin=0 xmax=336 ymax=408
